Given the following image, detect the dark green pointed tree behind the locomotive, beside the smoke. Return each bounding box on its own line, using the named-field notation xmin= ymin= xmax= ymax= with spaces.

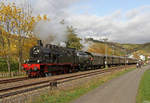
xmin=66 ymin=26 xmax=83 ymax=50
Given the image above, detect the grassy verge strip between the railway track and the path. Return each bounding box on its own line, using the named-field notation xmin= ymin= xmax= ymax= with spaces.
xmin=31 ymin=68 xmax=134 ymax=103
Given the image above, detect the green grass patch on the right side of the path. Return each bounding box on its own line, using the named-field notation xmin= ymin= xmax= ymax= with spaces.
xmin=136 ymin=70 xmax=150 ymax=103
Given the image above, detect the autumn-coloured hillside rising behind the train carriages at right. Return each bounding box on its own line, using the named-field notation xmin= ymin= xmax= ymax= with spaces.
xmin=88 ymin=40 xmax=150 ymax=57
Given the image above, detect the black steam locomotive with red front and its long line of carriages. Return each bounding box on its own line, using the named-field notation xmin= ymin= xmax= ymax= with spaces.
xmin=22 ymin=40 xmax=137 ymax=77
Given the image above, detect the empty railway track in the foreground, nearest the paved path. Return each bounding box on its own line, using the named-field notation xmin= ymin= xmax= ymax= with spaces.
xmin=0 ymin=67 xmax=134 ymax=99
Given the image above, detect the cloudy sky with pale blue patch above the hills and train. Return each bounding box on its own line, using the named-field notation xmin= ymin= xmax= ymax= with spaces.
xmin=12 ymin=0 xmax=150 ymax=43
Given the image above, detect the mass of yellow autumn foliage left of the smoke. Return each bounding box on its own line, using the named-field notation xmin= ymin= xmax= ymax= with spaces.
xmin=0 ymin=2 xmax=48 ymax=59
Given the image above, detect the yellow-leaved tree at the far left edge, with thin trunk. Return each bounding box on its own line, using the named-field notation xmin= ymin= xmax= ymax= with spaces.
xmin=0 ymin=2 xmax=14 ymax=72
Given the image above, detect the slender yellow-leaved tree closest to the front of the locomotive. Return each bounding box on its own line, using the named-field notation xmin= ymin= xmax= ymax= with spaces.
xmin=14 ymin=4 xmax=35 ymax=71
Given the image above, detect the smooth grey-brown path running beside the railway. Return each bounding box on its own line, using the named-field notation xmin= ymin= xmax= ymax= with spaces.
xmin=72 ymin=66 xmax=150 ymax=103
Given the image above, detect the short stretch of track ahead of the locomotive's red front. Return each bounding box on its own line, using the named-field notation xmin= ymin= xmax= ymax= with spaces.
xmin=0 ymin=77 xmax=29 ymax=84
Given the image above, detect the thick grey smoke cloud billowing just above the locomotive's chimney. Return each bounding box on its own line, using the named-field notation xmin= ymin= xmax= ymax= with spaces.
xmin=34 ymin=20 xmax=67 ymax=45
